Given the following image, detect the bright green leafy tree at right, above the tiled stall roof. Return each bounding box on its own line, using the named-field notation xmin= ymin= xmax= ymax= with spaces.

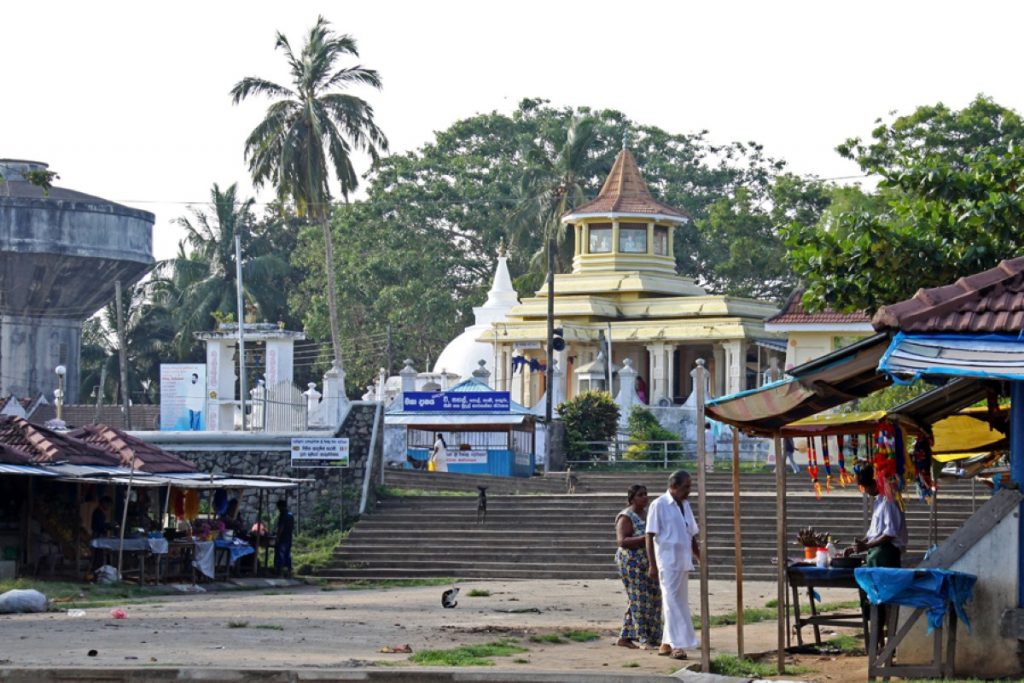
xmin=786 ymin=96 xmax=1024 ymax=310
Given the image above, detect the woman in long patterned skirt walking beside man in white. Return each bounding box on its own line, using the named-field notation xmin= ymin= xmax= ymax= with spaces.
xmin=615 ymin=484 xmax=662 ymax=648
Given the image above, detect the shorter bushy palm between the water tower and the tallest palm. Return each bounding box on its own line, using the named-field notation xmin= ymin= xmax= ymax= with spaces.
xmin=162 ymin=183 xmax=290 ymax=358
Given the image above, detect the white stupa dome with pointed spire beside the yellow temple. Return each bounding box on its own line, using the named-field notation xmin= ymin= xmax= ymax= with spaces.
xmin=434 ymin=248 xmax=519 ymax=379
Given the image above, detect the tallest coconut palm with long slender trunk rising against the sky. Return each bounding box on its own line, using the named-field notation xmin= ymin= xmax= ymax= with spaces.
xmin=230 ymin=16 xmax=387 ymax=368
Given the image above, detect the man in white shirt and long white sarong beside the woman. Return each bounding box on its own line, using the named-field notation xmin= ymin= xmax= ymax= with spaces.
xmin=646 ymin=470 xmax=700 ymax=659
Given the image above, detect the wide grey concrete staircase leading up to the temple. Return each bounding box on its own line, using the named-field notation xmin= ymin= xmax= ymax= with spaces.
xmin=319 ymin=472 xmax=974 ymax=580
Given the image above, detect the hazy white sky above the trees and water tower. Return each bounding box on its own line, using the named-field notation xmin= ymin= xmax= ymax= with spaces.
xmin=0 ymin=0 xmax=1024 ymax=258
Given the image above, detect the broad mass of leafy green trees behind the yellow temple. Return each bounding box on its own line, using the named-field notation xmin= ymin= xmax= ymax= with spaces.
xmin=291 ymin=99 xmax=822 ymax=386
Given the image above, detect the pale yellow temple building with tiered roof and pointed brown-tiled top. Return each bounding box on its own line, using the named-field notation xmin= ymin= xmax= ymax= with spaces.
xmin=487 ymin=145 xmax=785 ymax=405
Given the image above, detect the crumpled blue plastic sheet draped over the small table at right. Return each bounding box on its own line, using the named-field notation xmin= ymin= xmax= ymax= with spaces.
xmin=853 ymin=567 xmax=978 ymax=633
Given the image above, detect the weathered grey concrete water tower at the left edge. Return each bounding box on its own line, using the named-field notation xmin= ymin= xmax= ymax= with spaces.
xmin=0 ymin=159 xmax=154 ymax=403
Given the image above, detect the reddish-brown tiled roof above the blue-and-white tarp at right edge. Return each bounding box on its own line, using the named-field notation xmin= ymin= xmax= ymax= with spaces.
xmin=871 ymin=256 xmax=1024 ymax=334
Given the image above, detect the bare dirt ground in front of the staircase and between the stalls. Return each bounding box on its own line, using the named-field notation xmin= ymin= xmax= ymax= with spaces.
xmin=0 ymin=579 xmax=866 ymax=681
